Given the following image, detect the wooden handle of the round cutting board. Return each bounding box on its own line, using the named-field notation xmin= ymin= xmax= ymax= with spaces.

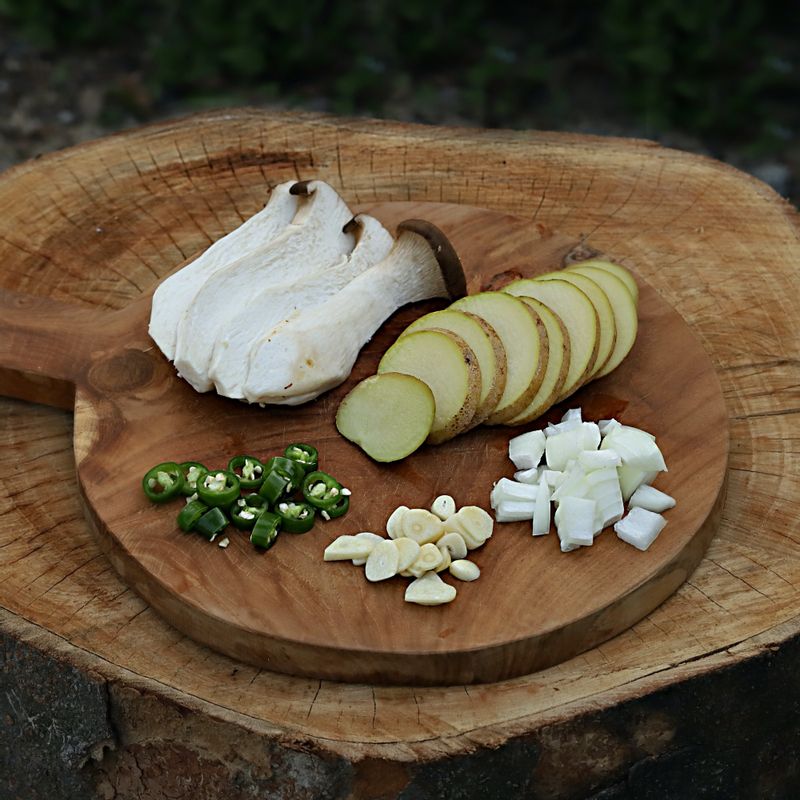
xmin=0 ymin=289 xmax=109 ymax=410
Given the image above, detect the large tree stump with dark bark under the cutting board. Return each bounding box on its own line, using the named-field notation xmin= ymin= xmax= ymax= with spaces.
xmin=0 ymin=110 xmax=800 ymax=800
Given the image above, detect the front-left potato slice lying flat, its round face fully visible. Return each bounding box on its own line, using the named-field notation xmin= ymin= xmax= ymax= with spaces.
xmin=336 ymin=372 xmax=436 ymax=461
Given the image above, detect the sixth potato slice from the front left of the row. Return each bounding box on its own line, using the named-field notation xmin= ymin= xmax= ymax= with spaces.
xmin=503 ymin=278 xmax=600 ymax=400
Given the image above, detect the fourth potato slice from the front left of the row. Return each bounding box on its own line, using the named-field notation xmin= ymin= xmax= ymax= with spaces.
xmin=450 ymin=292 xmax=548 ymax=425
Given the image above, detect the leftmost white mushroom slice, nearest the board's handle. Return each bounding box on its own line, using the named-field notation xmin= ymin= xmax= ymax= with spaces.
xmin=148 ymin=181 xmax=299 ymax=361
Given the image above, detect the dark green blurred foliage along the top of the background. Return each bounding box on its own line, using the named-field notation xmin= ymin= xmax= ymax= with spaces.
xmin=0 ymin=0 xmax=800 ymax=147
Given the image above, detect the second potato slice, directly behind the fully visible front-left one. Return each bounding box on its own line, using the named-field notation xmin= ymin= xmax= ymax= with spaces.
xmin=378 ymin=331 xmax=481 ymax=444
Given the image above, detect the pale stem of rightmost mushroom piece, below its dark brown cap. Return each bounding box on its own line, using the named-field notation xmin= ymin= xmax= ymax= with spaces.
xmin=243 ymin=230 xmax=460 ymax=405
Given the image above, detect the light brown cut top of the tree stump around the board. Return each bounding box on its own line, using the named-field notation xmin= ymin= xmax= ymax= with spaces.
xmin=0 ymin=111 xmax=800 ymax=776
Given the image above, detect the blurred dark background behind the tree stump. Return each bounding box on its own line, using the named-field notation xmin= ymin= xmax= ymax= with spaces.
xmin=0 ymin=0 xmax=800 ymax=204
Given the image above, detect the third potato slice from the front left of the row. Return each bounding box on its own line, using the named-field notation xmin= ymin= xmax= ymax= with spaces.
xmin=401 ymin=308 xmax=506 ymax=427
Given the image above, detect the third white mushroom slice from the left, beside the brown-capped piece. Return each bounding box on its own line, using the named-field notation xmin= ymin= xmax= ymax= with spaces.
xmin=209 ymin=215 xmax=392 ymax=399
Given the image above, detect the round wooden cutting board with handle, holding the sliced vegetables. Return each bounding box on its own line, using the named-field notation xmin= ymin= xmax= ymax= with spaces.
xmin=0 ymin=203 xmax=728 ymax=684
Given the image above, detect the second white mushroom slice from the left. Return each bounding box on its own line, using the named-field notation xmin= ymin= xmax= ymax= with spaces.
xmin=175 ymin=181 xmax=355 ymax=392
